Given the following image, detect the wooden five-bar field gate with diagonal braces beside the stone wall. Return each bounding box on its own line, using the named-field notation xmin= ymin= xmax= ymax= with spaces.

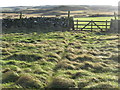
xmin=74 ymin=20 xmax=111 ymax=31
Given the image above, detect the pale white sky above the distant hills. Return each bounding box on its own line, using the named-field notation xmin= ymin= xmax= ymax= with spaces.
xmin=0 ymin=0 xmax=119 ymax=7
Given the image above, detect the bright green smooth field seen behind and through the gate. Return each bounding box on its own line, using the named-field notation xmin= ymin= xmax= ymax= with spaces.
xmin=74 ymin=17 xmax=114 ymax=28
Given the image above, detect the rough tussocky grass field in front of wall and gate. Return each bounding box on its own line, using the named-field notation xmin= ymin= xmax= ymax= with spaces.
xmin=0 ymin=32 xmax=120 ymax=90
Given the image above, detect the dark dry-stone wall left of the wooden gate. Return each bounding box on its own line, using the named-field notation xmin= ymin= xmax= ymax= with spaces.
xmin=2 ymin=17 xmax=73 ymax=29
